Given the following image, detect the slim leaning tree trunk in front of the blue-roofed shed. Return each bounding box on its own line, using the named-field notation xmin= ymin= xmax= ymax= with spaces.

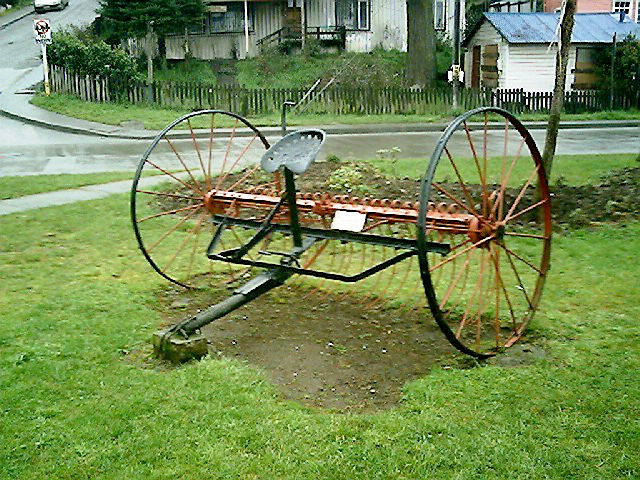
xmin=542 ymin=0 xmax=576 ymax=178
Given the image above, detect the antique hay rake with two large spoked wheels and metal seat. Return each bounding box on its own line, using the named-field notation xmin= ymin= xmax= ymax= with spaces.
xmin=131 ymin=107 xmax=551 ymax=357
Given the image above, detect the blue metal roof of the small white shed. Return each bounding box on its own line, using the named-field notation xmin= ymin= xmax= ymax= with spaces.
xmin=474 ymin=13 xmax=640 ymax=43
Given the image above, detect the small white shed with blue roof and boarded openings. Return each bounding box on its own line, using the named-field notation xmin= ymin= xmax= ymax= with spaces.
xmin=463 ymin=13 xmax=640 ymax=92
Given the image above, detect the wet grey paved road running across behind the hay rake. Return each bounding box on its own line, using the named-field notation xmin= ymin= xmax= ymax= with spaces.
xmin=0 ymin=124 xmax=640 ymax=176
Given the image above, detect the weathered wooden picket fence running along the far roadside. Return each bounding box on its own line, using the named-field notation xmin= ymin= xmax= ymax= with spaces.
xmin=50 ymin=66 xmax=640 ymax=116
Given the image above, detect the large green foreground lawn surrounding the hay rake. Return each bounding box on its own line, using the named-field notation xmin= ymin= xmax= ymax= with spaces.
xmin=0 ymin=172 xmax=640 ymax=479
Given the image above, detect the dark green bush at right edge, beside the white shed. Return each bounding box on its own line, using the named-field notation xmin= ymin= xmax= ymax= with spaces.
xmin=593 ymin=35 xmax=640 ymax=92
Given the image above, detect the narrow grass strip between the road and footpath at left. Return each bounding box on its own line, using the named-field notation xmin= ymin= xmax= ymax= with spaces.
xmin=0 ymin=172 xmax=141 ymax=200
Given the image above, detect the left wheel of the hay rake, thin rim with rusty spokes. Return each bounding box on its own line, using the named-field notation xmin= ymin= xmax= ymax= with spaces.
xmin=131 ymin=110 xmax=278 ymax=287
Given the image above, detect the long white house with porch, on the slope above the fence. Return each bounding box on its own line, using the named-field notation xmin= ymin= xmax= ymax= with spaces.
xmin=166 ymin=0 xmax=464 ymax=60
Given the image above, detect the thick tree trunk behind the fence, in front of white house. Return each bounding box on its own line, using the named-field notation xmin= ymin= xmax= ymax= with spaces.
xmin=407 ymin=0 xmax=436 ymax=87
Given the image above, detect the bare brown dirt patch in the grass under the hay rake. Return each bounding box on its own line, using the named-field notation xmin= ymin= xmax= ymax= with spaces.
xmin=161 ymin=284 xmax=456 ymax=411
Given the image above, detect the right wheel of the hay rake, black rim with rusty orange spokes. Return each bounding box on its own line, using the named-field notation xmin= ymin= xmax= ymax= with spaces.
xmin=417 ymin=107 xmax=551 ymax=357
